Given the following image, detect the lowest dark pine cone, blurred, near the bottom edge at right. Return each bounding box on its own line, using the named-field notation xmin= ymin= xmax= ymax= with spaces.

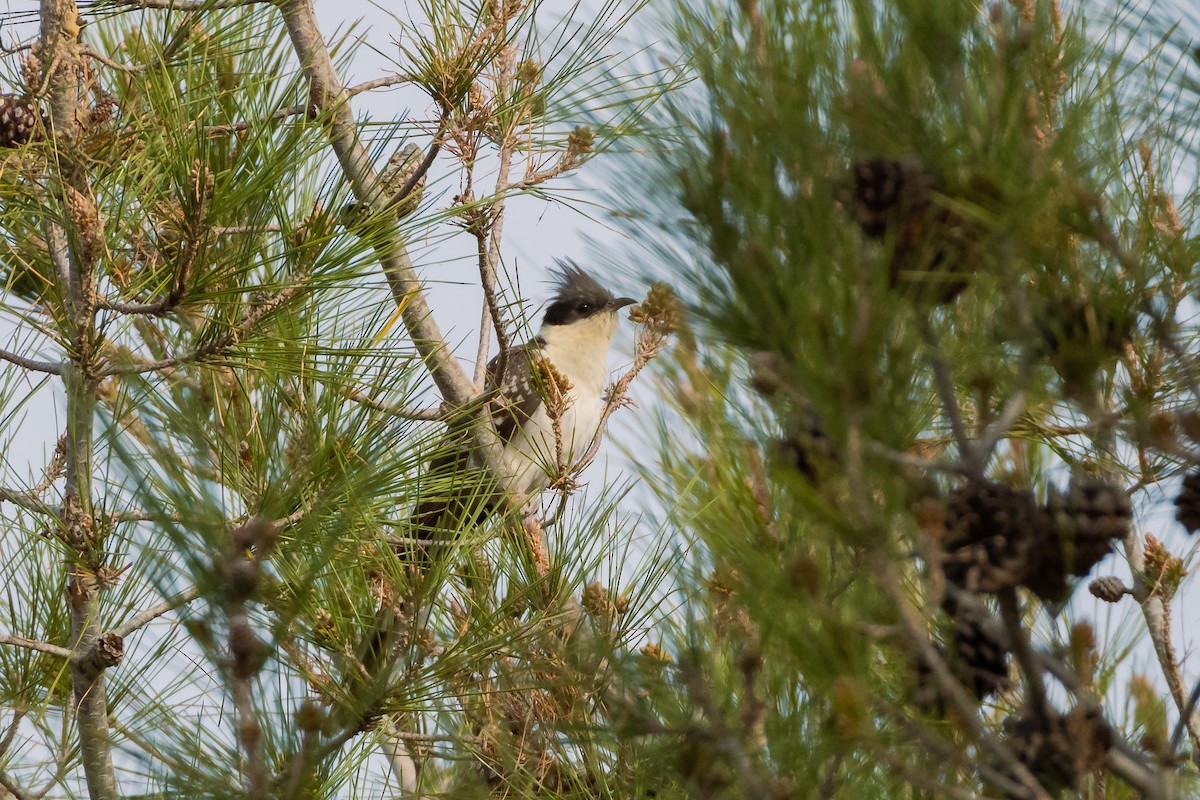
xmin=1004 ymin=706 xmax=1112 ymax=796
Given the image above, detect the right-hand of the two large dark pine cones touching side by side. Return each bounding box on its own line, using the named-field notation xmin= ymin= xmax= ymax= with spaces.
xmin=1025 ymin=479 xmax=1133 ymax=602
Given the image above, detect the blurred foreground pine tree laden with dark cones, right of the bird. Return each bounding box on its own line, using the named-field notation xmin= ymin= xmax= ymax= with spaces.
xmin=597 ymin=0 xmax=1200 ymax=799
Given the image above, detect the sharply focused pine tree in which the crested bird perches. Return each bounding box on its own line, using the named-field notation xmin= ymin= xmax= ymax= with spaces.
xmin=0 ymin=0 xmax=667 ymax=800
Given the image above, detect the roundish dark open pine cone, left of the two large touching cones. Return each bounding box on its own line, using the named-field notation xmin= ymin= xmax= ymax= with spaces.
xmin=943 ymin=483 xmax=1043 ymax=593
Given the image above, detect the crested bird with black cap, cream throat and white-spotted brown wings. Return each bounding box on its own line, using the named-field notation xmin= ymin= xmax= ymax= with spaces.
xmin=409 ymin=259 xmax=637 ymax=554
